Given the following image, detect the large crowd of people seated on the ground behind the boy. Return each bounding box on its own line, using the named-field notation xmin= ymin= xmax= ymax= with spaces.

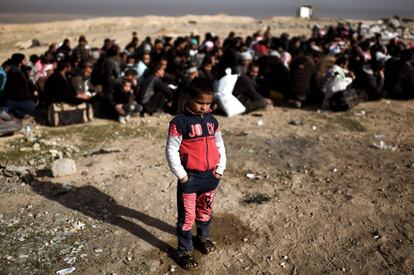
xmin=0 ymin=23 xmax=414 ymax=135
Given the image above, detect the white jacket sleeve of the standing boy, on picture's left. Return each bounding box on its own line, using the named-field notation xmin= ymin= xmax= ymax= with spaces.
xmin=165 ymin=122 xmax=187 ymax=179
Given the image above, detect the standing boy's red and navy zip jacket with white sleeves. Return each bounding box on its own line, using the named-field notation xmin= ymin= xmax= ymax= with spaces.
xmin=165 ymin=106 xmax=226 ymax=179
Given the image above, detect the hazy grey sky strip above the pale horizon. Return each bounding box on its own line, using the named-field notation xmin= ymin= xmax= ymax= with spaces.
xmin=0 ymin=0 xmax=414 ymax=19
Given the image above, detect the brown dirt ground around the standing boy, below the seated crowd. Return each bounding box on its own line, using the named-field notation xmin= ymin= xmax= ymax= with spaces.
xmin=0 ymin=100 xmax=414 ymax=274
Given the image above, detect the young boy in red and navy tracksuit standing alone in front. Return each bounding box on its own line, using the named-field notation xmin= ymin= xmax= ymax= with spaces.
xmin=166 ymin=78 xmax=226 ymax=269
